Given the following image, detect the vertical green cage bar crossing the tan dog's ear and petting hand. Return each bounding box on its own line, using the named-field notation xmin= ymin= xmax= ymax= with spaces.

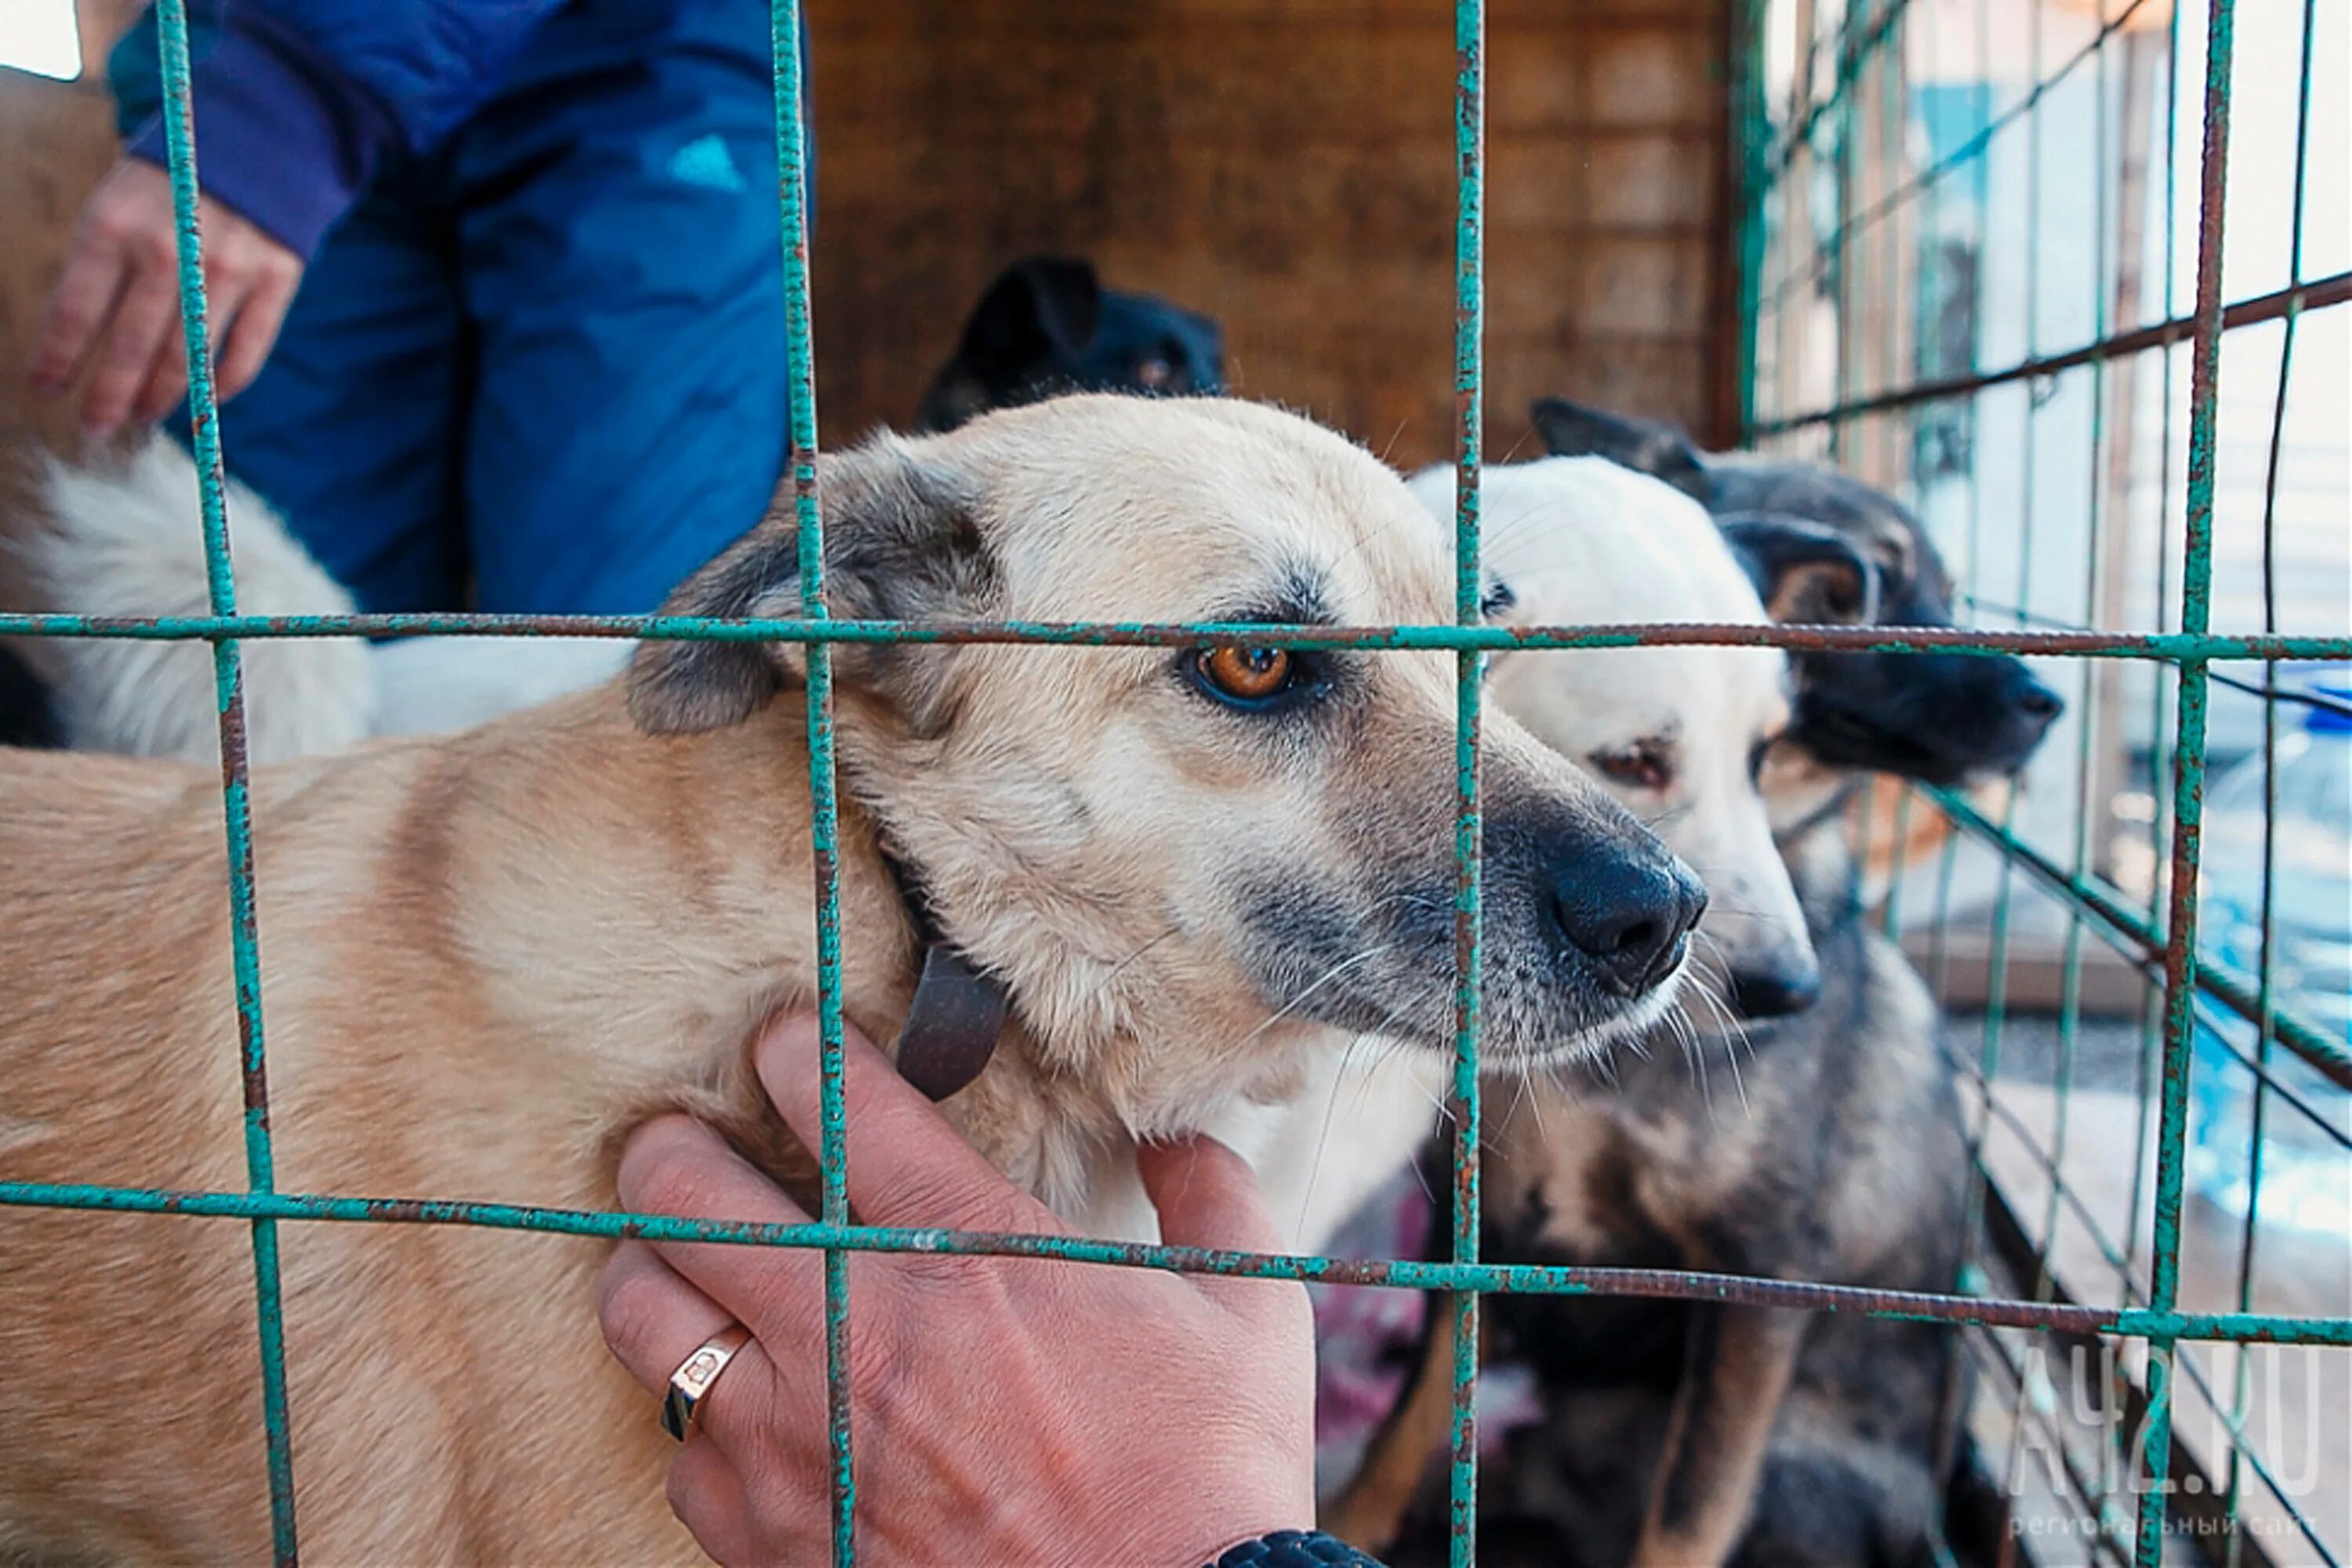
xmin=769 ymin=0 xmax=858 ymax=1568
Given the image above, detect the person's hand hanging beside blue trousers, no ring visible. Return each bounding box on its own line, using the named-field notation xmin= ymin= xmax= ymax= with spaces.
xmin=28 ymin=158 xmax=303 ymax=437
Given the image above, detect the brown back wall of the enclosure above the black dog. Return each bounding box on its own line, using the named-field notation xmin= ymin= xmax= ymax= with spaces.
xmin=809 ymin=0 xmax=1731 ymax=463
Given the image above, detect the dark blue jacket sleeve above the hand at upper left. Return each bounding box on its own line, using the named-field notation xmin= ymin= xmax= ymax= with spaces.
xmin=129 ymin=0 xmax=567 ymax=259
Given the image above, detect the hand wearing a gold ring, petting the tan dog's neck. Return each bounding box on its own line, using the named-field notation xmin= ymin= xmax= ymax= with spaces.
xmin=597 ymin=1018 xmax=1336 ymax=1566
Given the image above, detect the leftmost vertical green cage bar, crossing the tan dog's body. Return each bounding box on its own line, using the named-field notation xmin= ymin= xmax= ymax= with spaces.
xmin=155 ymin=0 xmax=299 ymax=1566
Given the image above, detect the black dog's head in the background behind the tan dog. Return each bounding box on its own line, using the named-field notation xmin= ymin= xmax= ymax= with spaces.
xmin=915 ymin=256 xmax=1225 ymax=430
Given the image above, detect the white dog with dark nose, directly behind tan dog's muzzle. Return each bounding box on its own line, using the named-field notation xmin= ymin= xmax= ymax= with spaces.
xmin=1284 ymin=459 xmax=1818 ymax=1246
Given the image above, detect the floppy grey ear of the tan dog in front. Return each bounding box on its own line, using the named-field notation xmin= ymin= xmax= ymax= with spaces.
xmin=628 ymin=437 xmax=1002 ymax=736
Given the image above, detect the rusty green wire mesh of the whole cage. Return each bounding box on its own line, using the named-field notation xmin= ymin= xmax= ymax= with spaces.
xmin=0 ymin=0 xmax=2352 ymax=1563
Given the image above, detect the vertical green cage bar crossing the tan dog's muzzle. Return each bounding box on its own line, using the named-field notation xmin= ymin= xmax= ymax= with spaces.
xmin=1446 ymin=0 xmax=1486 ymax=1568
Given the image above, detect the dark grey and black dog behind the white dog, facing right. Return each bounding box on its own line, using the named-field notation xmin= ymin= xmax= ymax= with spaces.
xmin=1364 ymin=400 xmax=2060 ymax=1568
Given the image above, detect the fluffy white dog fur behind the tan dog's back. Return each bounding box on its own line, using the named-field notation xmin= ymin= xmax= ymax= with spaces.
xmin=14 ymin=433 xmax=635 ymax=764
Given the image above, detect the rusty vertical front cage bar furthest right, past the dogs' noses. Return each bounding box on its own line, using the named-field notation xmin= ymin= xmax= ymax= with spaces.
xmin=2138 ymin=0 xmax=2237 ymax=1568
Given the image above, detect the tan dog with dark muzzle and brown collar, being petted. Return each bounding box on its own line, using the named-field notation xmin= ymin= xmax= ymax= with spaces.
xmin=0 ymin=397 xmax=1700 ymax=1563
